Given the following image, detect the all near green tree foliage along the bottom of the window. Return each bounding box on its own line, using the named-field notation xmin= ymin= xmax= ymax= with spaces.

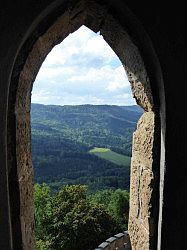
xmin=35 ymin=184 xmax=128 ymax=250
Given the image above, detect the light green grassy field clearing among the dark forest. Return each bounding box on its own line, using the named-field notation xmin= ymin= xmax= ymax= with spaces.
xmin=89 ymin=148 xmax=131 ymax=166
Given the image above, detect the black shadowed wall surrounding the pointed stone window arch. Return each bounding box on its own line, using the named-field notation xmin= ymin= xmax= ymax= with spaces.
xmin=0 ymin=0 xmax=187 ymax=250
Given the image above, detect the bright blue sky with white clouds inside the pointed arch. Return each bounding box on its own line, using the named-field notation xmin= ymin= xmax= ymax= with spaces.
xmin=31 ymin=26 xmax=136 ymax=106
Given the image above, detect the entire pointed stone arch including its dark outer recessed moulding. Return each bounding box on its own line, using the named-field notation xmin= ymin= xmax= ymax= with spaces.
xmin=7 ymin=0 xmax=164 ymax=250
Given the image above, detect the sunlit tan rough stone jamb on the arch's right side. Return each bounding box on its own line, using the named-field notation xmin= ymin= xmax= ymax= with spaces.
xmin=129 ymin=112 xmax=155 ymax=250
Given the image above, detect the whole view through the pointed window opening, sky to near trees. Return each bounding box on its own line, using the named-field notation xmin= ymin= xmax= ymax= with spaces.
xmin=31 ymin=26 xmax=143 ymax=250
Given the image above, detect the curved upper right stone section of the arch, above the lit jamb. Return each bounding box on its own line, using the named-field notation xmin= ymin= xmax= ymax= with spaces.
xmin=101 ymin=15 xmax=154 ymax=111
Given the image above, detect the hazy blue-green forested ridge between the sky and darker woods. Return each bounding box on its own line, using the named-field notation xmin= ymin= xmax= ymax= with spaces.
xmin=31 ymin=104 xmax=142 ymax=155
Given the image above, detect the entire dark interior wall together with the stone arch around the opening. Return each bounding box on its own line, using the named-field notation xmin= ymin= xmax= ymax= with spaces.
xmin=3 ymin=0 xmax=183 ymax=250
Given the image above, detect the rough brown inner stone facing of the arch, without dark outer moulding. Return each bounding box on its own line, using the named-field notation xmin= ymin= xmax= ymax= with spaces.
xmin=6 ymin=0 xmax=158 ymax=250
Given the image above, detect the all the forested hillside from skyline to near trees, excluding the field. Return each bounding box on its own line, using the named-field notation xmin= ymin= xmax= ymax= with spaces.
xmin=31 ymin=104 xmax=142 ymax=192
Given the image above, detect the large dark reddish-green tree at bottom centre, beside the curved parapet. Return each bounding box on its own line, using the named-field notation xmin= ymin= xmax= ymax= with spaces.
xmin=50 ymin=185 xmax=121 ymax=250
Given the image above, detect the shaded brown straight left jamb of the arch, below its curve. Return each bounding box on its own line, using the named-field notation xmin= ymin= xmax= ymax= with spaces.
xmin=16 ymin=110 xmax=34 ymax=250
